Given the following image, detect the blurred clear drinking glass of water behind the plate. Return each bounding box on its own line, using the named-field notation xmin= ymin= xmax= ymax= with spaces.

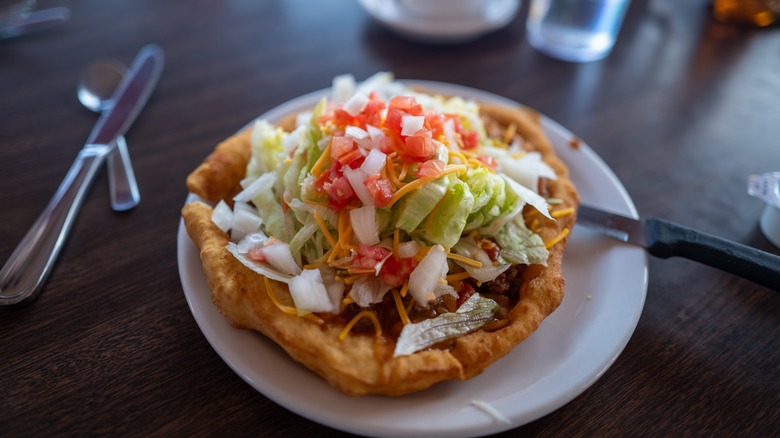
xmin=526 ymin=0 xmax=631 ymax=62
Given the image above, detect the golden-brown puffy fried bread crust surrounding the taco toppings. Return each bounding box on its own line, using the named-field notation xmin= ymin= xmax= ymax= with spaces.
xmin=182 ymin=100 xmax=579 ymax=396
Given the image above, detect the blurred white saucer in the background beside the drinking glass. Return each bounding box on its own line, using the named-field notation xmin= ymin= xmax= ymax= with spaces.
xmin=360 ymin=0 xmax=520 ymax=44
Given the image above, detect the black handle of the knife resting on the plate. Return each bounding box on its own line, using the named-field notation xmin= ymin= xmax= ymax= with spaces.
xmin=645 ymin=218 xmax=780 ymax=292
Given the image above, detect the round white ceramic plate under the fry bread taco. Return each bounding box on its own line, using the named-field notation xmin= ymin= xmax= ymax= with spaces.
xmin=178 ymin=81 xmax=647 ymax=437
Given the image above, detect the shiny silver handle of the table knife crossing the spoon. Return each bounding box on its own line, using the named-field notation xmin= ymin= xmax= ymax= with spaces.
xmin=0 ymin=145 xmax=112 ymax=306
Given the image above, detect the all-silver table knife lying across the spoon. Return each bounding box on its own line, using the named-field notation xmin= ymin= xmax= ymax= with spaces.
xmin=0 ymin=44 xmax=163 ymax=306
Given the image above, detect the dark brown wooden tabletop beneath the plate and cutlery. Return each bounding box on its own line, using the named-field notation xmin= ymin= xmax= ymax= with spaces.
xmin=0 ymin=0 xmax=780 ymax=436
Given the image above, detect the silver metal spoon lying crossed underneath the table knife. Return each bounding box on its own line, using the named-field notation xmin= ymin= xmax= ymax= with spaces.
xmin=78 ymin=59 xmax=141 ymax=211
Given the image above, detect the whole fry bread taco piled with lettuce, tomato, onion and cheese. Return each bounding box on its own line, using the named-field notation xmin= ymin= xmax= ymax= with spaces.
xmin=182 ymin=73 xmax=578 ymax=395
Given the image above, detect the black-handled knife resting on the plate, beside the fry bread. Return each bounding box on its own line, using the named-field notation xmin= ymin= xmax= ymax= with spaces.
xmin=576 ymin=205 xmax=780 ymax=291
